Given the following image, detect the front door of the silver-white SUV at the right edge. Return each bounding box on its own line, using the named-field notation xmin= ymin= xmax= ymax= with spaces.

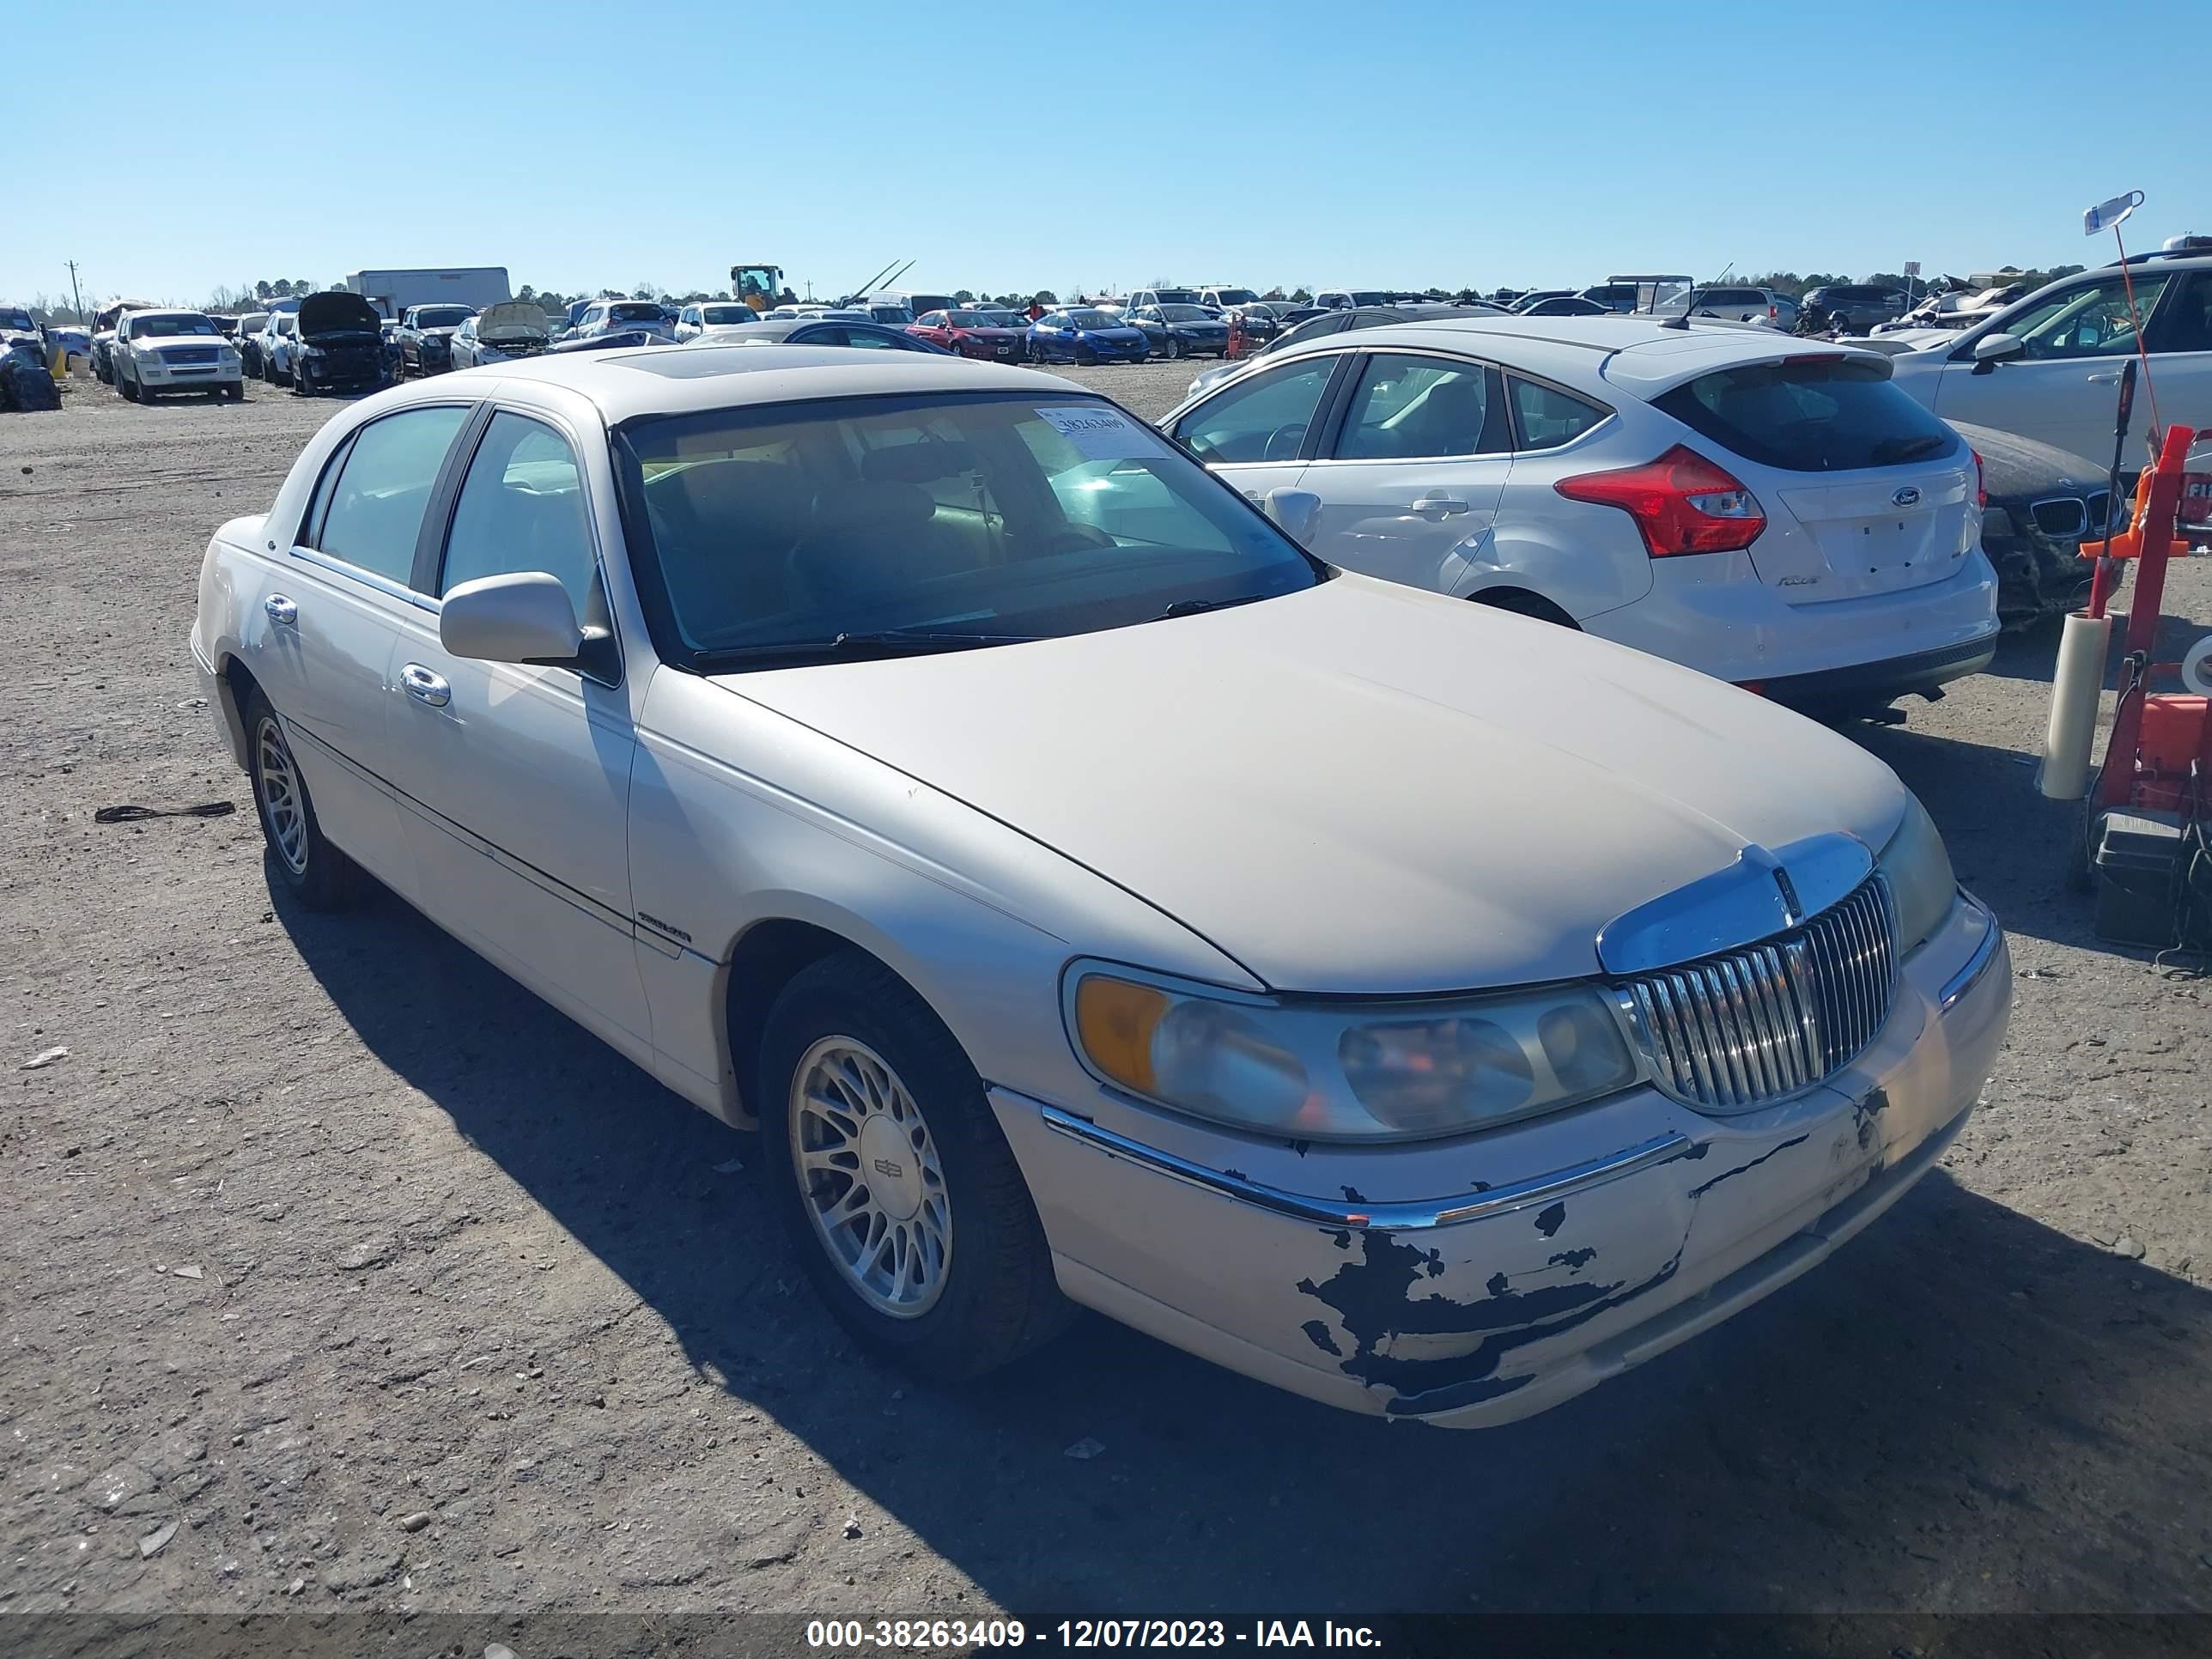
xmin=1933 ymin=265 xmax=2201 ymax=460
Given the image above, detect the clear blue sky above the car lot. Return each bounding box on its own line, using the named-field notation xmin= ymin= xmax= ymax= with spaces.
xmin=0 ymin=0 xmax=2212 ymax=312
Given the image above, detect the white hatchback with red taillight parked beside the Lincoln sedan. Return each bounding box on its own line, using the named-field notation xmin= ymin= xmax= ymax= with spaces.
xmin=1161 ymin=316 xmax=1997 ymax=710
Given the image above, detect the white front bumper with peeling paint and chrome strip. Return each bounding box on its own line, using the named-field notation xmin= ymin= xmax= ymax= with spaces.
xmin=991 ymin=896 xmax=2011 ymax=1427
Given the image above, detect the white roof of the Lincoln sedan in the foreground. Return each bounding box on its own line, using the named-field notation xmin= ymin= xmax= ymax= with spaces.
xmin=424 ymin=343 xmax=1091 ymax=427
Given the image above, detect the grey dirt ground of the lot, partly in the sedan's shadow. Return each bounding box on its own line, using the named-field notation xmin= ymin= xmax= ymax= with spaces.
xmin=0 ymin=365 xmax=2212 ymax=1659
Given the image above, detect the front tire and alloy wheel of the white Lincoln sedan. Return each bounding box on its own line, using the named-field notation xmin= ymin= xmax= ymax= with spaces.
xmin=759 ymin=951 xmax=1073 ymax=1380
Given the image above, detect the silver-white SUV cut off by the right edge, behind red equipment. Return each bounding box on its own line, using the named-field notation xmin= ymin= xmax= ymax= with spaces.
xmin=1878 ymin=237 xmax=2212 ymax=465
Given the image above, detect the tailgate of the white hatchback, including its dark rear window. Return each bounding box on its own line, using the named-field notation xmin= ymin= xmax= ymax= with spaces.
xmin=1652 ymin=352 xmax=1982 ymax=604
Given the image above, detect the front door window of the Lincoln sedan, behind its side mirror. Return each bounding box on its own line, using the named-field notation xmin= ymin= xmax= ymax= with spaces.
xmin=438 ymin=410 xmax=604 ymax=622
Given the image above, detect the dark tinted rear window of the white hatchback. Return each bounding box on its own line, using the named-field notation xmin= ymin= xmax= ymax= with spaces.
xmin=1652 ymin=356 xmax=1960 ymax=473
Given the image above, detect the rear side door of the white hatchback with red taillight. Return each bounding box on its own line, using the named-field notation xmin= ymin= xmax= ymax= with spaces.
xmin=1298 ymin=352 xmax=1513 ymax=592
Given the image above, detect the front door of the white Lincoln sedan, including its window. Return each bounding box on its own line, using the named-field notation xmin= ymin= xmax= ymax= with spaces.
xmin=375 ymin=410 xmax=653 ymax=1053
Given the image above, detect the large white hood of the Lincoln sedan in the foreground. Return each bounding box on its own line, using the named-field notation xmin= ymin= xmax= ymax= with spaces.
xmin=719 ymin=575 xmax=1905 ymax=994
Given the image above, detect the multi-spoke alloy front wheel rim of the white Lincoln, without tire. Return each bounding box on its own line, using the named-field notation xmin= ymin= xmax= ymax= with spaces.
xmin=787 ymin=1036 xmax=953 ymax=1318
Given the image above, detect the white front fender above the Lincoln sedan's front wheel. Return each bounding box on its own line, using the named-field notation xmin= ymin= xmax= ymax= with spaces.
xmin=630 ymin=671 xmax=1259 ymax=1121
